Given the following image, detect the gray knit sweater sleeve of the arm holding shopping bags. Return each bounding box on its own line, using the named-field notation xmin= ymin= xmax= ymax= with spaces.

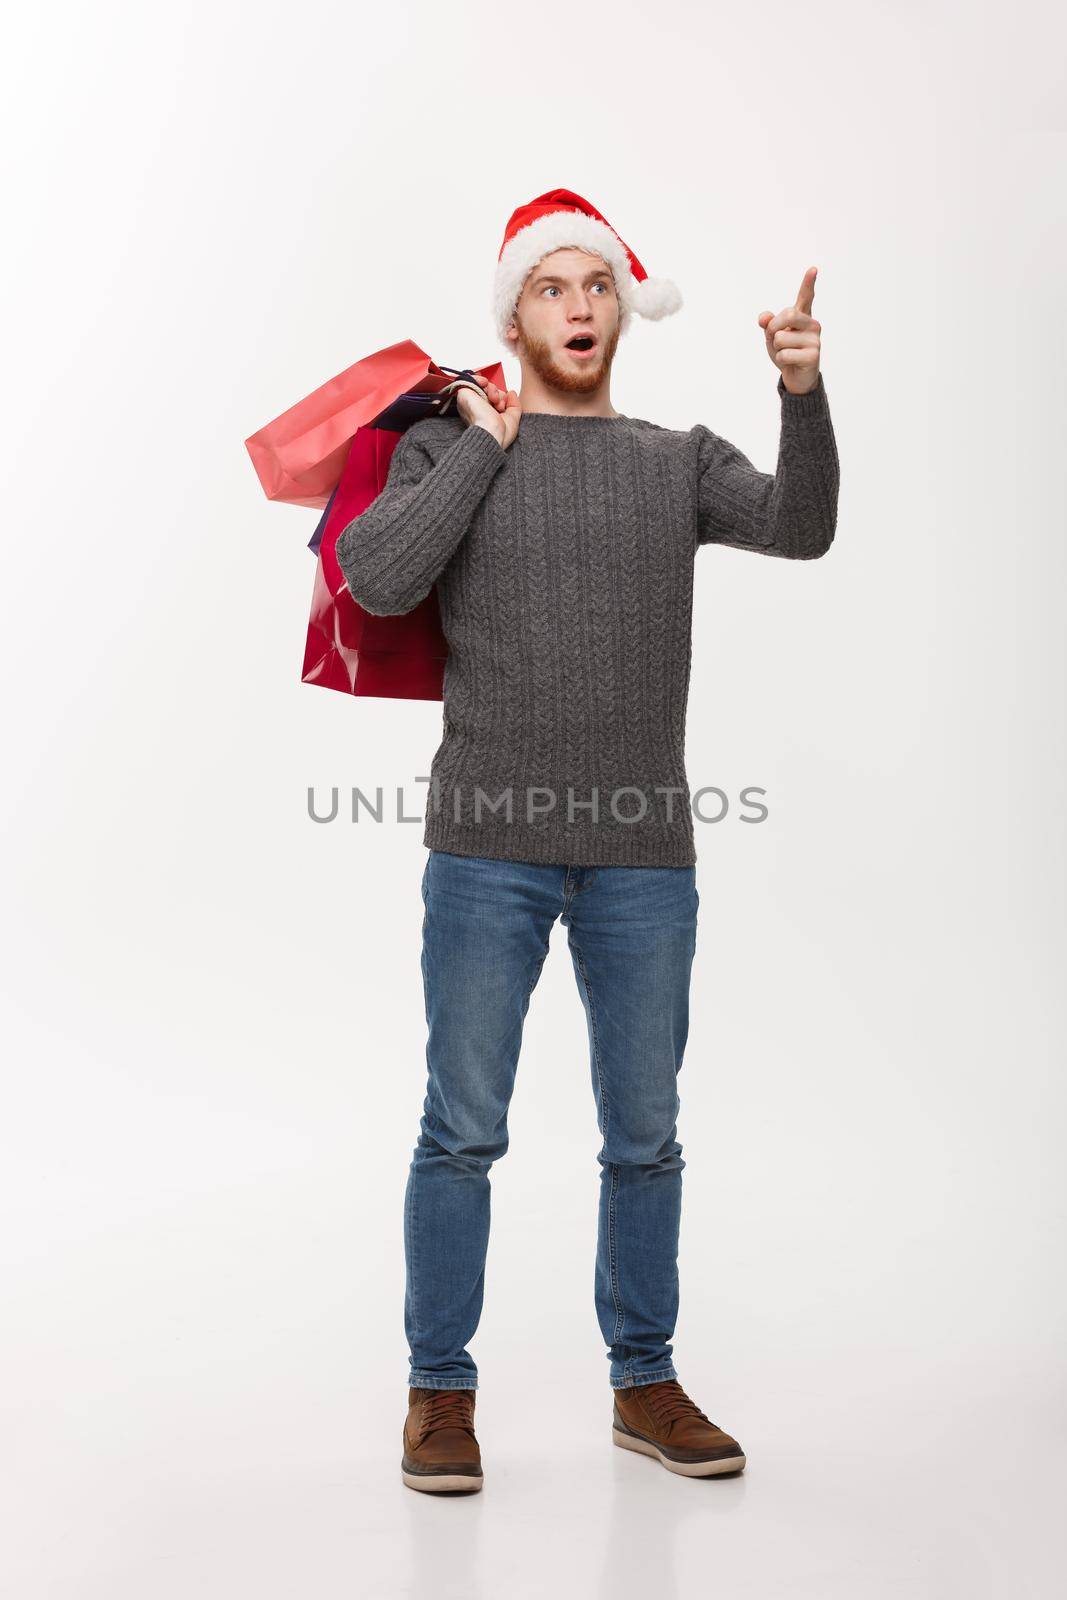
xmin=336 ymin=422 xmax=507 ymax=616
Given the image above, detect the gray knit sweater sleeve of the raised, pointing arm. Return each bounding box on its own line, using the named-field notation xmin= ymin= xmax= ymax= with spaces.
xmin=693 ymin=373 xmax=840 ymax=562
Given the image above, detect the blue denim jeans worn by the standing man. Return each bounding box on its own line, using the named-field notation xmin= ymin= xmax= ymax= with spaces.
xmin=403 ymin=850 xmax=699 ymax=1389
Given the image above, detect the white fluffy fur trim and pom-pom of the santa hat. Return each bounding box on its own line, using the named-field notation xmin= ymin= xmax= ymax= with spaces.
xmin=493 ymin=211 xmax=681 ymax=352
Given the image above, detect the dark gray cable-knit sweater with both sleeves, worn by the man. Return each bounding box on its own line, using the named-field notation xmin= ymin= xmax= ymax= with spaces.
xmin=338 ymin=376 xmax=838 ymax=867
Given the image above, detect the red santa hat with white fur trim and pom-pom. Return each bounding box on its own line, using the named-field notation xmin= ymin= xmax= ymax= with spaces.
xmin=493 ymin=189 xmax=681 ymax=352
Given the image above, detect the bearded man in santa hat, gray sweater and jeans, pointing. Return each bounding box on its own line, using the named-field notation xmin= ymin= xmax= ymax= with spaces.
xmin=338 ymin=189 xmax=838 ymax=1491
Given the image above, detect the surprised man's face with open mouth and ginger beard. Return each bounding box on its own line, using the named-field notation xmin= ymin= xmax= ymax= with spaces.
xmin=512 ymin=248 xmax=619 ymax=394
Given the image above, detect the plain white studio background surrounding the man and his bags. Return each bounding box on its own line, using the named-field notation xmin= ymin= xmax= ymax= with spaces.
xmin=0 ymin=0 xmax=1067 ymax=1600
